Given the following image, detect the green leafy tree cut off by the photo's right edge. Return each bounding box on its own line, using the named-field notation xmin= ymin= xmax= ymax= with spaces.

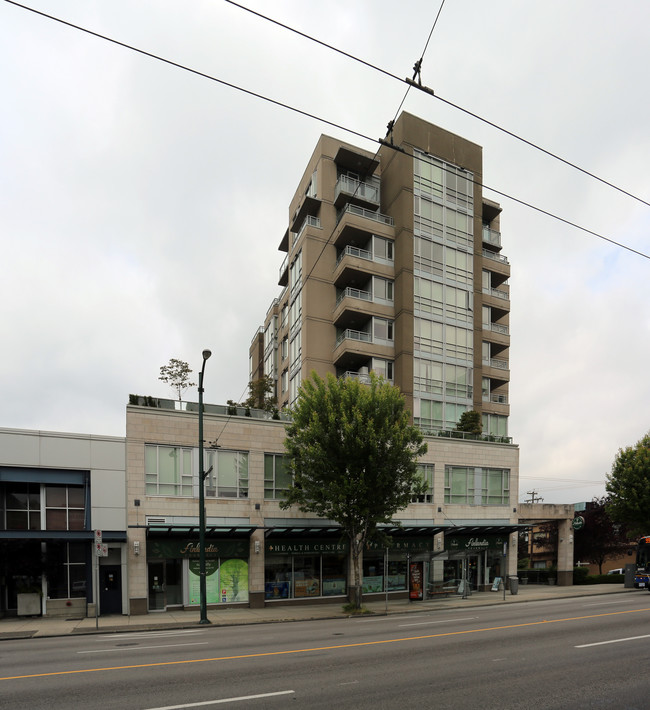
xmin=605 ymin=432 xmax=650 ymax=535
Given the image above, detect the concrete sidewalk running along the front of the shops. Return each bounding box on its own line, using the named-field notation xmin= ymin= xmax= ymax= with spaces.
xmin=0 ymin=584 xmax=644 ymax=641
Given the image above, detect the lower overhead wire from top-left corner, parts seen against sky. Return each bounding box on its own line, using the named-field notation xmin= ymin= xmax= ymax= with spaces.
xmin=5 ymin=0 xmax=650 ymax=259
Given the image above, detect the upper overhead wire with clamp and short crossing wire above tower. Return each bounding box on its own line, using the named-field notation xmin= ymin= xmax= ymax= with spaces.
xmin=225 ymin=0 xmax=650 ymax=207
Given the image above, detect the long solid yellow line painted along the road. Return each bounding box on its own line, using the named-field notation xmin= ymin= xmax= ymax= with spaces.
xmin=0 ymin=608 xmax=650 ymax=681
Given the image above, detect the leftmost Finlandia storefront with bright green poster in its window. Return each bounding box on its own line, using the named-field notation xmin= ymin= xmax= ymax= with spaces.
xmin=147 ymin=533 xmax=250 ymax=611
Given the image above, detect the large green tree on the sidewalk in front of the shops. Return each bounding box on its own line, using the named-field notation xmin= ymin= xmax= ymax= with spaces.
xmin=281 ymin=373 xmax=427 ymax=608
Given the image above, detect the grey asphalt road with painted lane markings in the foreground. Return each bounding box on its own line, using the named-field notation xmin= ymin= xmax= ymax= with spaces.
xmin=0 ymin=592 xmax=650 ymax=710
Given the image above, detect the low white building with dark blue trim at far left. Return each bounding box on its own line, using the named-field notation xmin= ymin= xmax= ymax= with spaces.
xmin=0 ymin=429 xmax=126 ymax=617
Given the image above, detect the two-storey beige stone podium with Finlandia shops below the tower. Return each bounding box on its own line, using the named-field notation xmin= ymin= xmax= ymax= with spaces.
xmin=126 ymin=398 xmax=519 ymax=614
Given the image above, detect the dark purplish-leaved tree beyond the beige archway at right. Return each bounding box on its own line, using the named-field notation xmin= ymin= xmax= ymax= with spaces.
xmin=573 ymin=497 xmax=630 ymax=574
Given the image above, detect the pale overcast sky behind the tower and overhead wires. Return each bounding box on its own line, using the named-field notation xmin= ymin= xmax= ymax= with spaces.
xmin=0 ymin=0 xmax=650 ymax=503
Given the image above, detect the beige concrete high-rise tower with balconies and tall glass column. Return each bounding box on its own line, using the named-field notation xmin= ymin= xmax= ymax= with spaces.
xmin=249 ymin=113 xmax=510 ymax=440
